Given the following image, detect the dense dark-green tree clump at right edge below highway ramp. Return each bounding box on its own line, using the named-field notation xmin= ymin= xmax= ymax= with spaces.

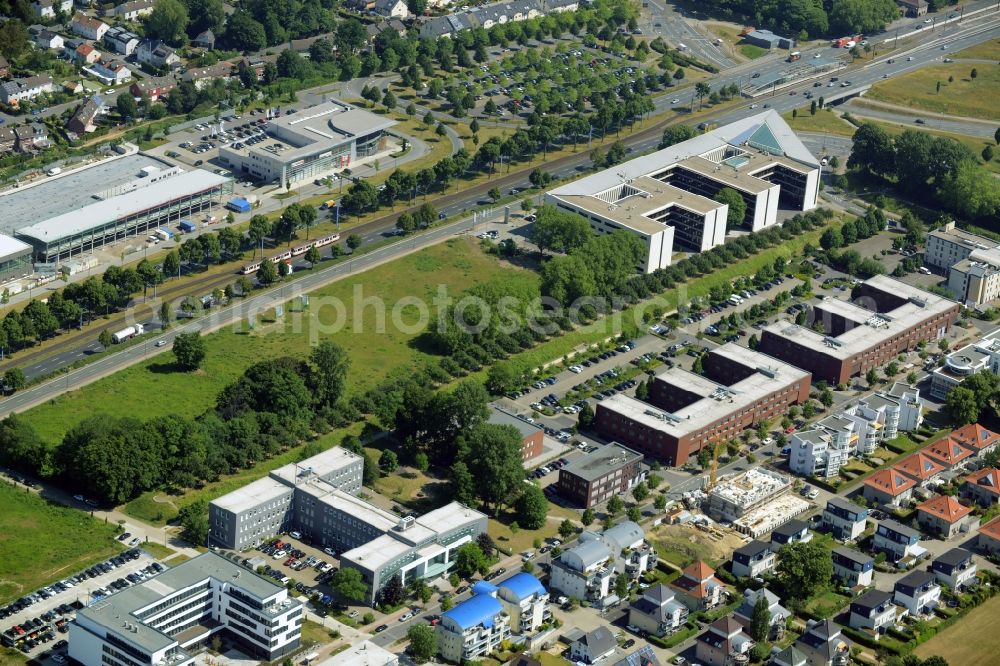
xmin=847 ymin=123 xmax=1000 ymax=220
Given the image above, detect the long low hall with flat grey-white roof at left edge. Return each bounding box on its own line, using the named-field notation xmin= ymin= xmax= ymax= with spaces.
xmin=6 ymin=154 xmax=232 ymax=263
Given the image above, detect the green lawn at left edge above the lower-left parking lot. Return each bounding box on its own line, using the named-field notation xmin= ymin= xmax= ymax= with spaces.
xmin=0 ymin=483 xmax=122 ymax=604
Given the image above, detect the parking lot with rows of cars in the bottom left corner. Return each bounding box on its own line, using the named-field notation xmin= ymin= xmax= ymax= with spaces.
xmin=0 ymin=548 xmax=157 ymax=664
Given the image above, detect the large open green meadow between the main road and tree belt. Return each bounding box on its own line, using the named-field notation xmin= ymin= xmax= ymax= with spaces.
xmin=23 ymin=239 xmax=538 ymax=443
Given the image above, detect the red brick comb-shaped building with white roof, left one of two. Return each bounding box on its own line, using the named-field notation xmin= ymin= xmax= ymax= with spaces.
xmin=595 ymin=343 xmax=811 ymax=467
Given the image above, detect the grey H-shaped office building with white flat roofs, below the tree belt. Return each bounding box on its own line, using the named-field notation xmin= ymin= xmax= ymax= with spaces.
xmin=208 ymin=447 xmax=487 ymax=602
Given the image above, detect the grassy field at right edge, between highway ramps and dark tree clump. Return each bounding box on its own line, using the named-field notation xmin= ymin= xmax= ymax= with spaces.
xmin=867 ymin=63 xmax=1000 ymax=120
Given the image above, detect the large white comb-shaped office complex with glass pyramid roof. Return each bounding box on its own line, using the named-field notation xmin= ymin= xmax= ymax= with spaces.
xmin=545 ymin=111 xmax=820 ymax=273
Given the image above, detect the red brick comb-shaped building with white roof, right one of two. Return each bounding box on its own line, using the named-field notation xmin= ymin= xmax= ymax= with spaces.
xmin=757 ymin=275 xmax=959 ymax=384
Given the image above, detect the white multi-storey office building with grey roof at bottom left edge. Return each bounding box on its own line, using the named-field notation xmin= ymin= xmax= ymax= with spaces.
xmin=69 ymin=552 xmax=302 ymax=666
